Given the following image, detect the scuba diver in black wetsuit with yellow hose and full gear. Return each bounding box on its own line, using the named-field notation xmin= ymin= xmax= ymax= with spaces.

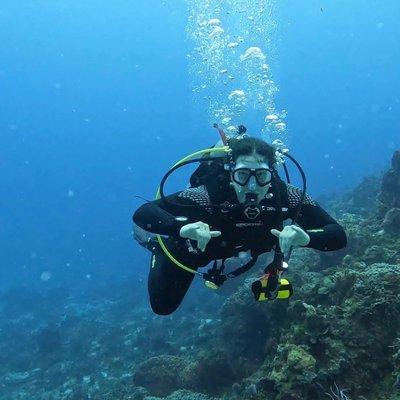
xmin=132 ymin=125 xmax=347 ymax=315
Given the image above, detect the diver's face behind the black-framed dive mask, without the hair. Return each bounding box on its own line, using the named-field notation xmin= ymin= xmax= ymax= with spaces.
xmin=231 ymin=153 xmax=272 ymax=204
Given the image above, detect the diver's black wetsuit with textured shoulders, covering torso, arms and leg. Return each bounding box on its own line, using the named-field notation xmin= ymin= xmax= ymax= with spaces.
xmin=133 ymin=181 xmax=347 ymax=315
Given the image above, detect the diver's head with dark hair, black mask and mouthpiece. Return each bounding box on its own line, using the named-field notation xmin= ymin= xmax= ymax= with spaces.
xmin=229 ymin=137 xmax=275 ymax=204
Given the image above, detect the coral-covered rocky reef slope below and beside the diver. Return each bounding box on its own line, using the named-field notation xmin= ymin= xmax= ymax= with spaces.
xmin=0 ymin=151 xmax=400 ymax=400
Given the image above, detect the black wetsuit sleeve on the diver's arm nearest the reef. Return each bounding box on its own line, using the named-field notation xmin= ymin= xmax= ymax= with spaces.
xmin=288 ymin=187 xmax=347 ymax=251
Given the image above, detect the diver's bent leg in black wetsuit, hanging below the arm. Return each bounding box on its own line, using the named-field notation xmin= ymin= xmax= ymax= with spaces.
xmin=148 ymin=241 xmax=196 ymax=315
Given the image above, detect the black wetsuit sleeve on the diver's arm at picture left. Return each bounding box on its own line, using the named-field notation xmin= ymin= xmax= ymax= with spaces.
xmin=132 ymin=189 xmax=208 ymax=237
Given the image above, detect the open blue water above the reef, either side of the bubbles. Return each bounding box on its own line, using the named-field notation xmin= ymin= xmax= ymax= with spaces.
xmin=0 ymin=0 xmax=400 ymax=286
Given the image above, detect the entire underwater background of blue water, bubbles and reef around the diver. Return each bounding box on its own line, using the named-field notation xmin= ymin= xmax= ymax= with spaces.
xmin=0 ymin=0 xmax=400 ymax=400
